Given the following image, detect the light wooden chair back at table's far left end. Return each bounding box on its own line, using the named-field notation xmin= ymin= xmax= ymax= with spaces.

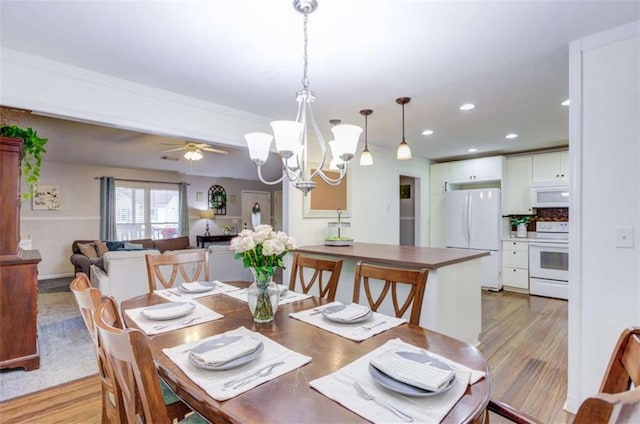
xmin=145 ymin=249 xmax=209 ymax=293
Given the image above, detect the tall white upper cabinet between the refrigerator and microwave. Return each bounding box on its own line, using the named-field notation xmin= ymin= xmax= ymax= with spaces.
xmin=502 ymin=156 xmax=533 ymax=215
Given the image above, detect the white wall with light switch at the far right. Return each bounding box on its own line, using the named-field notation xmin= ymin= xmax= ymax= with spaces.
xmin=567 ymin=22 xmax=640 ymax=411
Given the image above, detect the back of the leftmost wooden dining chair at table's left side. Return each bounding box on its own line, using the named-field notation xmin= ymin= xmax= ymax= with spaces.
xmin=70 ymin=272 xmax=124 ymax=423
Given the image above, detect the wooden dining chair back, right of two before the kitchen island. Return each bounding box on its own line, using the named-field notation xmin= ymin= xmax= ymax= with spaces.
xmin=353 ymin=261 xmax=429 ymax=325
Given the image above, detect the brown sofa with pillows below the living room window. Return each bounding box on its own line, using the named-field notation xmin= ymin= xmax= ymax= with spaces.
xmin=69 ymin=236 xmax=192 ymax=275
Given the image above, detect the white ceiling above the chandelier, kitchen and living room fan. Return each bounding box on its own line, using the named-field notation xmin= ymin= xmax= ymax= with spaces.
xmin=0 ymin=0 xmax=640 ymax=178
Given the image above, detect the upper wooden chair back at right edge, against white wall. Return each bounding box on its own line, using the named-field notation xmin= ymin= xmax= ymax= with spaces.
xmin=600 ymin=327 xmax=640 ymax=393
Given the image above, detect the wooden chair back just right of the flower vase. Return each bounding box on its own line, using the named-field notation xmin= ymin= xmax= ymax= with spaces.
xmin=289 ymin=253 xmax=343 ymax=302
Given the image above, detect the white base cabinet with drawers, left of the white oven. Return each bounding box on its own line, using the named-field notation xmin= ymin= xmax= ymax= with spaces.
xmin=502 ymin=240 xmax=529 ymax=293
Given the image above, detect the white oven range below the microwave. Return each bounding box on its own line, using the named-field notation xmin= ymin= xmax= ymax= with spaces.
xmin=529 ymin=221 xmax=569 ymax=299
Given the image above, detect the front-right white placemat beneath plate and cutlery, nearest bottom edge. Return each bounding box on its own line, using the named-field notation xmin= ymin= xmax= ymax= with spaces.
xmin=309 ymin=339 xmax=484 ymax=423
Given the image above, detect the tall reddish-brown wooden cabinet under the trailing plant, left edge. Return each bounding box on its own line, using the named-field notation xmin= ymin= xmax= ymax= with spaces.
xmin=0 ymin=137 xmax=41 ymax=371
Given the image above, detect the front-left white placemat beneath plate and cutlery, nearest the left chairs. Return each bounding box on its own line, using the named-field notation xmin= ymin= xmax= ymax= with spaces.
xmin=163 ymin=327 xmax=311 ymax=400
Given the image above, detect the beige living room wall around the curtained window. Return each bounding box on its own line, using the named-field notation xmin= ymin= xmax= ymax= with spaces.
xmin=20 ymin=161 xmax=276 ymax=279
